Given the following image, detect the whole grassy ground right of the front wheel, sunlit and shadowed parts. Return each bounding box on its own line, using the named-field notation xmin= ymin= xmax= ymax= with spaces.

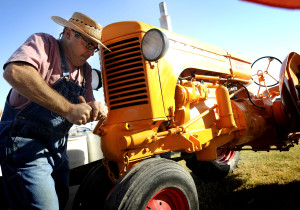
xmin=185 ymin=145 xmax=300 ymax=210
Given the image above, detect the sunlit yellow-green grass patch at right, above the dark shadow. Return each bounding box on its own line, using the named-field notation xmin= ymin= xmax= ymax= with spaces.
xmin=236 ymin=145 xmax=300 ymax=187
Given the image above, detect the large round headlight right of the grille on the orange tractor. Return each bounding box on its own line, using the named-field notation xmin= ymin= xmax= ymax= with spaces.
xmin=142 ymin=29 xmax=169 ymax=61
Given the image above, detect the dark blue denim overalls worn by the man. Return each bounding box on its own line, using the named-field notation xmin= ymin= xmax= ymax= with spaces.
xmin=0 ymin=78 xmax=85 ymax=210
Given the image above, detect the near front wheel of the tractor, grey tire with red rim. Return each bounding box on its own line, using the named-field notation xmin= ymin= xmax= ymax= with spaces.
xmin=105 ymin=158 xmax=199 ymax=210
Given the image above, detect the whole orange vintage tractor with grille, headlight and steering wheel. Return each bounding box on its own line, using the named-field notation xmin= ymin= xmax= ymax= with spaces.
xmin=73 ymin=21 xmax=300 ymax=210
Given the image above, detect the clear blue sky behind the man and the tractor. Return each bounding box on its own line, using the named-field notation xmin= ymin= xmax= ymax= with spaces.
xmin=0 ymin=0 xmax=300 ymax=109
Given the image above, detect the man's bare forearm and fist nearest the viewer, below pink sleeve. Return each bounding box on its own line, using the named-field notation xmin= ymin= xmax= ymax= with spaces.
xmin=3 ymin=62 xmax=92 ymax=125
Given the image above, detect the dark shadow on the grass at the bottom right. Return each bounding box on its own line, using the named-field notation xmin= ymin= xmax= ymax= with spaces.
xmin=192 ymin=174 xmax=300 ymax=210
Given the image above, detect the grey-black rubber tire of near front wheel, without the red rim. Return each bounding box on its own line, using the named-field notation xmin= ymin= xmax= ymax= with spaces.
xmin=105 ymin=158 xmax=199 ymax=210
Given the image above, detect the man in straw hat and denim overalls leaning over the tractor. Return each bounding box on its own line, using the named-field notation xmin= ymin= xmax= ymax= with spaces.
xmin=0 ymin=12 xmax=108 ymax=210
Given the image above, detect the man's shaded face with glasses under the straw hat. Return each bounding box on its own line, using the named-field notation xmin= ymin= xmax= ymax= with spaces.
xmin=65 ymin=28 xmax=98 ymax=66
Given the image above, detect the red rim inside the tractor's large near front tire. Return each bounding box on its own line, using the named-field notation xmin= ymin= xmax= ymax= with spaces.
xmin=145 ymin=187 xmax=189 ymax=210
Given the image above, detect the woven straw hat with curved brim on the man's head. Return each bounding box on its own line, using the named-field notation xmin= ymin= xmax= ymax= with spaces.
xmin=51 ymin=12 xmax=110 ymax=51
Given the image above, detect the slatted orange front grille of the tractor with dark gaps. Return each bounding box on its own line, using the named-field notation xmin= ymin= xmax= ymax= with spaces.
xmin=104 ymin=37 xmax=148 ymax=110
